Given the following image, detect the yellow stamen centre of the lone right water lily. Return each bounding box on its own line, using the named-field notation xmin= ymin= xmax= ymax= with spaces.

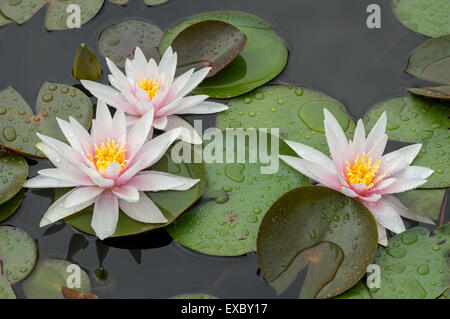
xmin=345 ymin=153 xmax=382 ymax=188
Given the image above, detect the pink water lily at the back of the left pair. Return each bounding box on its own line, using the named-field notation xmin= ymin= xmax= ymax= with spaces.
xmin=81 ymin=47 xmax=228 ymax=144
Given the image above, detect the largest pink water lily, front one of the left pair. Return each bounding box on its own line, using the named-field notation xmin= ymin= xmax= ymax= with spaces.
xmin=24 ymin=101 xmax=199 ymax=239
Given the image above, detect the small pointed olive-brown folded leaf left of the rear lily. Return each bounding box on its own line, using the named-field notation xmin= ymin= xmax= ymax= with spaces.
xmin=73 ymin=43 xmax=102 ymax=81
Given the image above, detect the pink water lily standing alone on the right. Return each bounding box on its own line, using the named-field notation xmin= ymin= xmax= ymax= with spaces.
xmin=280 ymin=109 xmax=434 ymax=245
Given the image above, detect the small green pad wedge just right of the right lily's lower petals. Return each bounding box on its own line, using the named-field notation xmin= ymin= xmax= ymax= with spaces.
xmin=396 ymin=188 xmax=446 ymax=219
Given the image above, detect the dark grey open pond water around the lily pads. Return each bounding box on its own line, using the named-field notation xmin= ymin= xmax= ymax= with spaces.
xmin=0 ymin=0 xmax=449 ymax=298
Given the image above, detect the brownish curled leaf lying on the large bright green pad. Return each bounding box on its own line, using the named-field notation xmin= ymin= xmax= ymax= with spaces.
xmin=172 ymin=20 xmax=247 ymax=77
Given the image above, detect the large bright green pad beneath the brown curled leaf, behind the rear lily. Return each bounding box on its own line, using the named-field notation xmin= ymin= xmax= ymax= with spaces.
xmin=159 ymin=11 xmax=288 ymax=98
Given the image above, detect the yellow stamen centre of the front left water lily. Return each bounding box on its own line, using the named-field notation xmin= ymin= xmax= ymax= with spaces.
xmin=86 ymin=137 xmax=128 ymax=174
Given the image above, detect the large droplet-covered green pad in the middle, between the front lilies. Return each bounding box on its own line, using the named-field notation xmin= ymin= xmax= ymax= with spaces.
xmin=166 ymin=131 xmax=309 ymax=256
